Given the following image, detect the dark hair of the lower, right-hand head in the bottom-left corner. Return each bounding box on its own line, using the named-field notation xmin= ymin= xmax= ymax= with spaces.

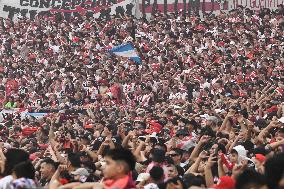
xmin=13 ymin=161 xmax=35 ymax=179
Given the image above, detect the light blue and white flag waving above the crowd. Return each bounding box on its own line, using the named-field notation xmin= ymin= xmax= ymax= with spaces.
xmin=109 ymin=43 xmax=142 ymax=64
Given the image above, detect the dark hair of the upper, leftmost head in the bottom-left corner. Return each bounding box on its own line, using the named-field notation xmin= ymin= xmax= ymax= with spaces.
xmin=3 ymin=148 xmax=29 ymax=176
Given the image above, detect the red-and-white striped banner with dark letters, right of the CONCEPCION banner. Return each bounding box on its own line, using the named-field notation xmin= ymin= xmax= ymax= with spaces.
xmin=139 ymin=0 xmax=228 ymax=16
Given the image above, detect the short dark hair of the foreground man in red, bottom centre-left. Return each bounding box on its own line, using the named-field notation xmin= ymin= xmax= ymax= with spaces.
xmin=105 ymin=148 xmax=136 ymax=171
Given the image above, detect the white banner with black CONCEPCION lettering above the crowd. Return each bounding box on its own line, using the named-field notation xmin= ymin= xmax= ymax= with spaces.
xmin=0 ymin=0 xmax=135 ymax=20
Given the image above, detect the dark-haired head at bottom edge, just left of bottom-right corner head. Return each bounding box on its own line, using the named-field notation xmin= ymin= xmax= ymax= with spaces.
xmin=236 ymin=169 xmax=266 ymax=189
